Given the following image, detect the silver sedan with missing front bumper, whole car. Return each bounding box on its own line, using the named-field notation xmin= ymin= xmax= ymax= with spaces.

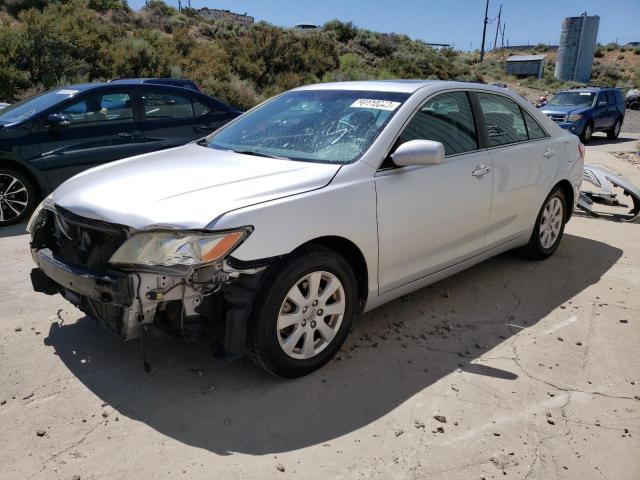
xmin=29 ymin=81 xmax=584 ymax=377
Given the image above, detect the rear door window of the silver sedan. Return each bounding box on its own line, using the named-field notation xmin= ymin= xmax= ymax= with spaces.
xmin=478 ymin=93 xmax=528 ymax=147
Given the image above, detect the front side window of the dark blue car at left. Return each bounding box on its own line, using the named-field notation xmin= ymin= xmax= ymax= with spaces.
xmin=58 ymin=92 xmax=133 ymax=125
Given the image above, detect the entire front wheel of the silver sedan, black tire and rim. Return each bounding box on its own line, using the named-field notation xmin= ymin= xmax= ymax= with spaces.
xmin=247 ymin=246 xmax=358 ymax=378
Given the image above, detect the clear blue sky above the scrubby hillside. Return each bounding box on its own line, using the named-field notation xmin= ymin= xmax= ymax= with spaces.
xmin=129 ymin=0 xmax=640 ymax=50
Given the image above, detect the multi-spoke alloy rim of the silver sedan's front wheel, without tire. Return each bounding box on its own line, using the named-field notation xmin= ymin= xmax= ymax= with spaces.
xmin=276 ymin=271 xmax=346 ymax=360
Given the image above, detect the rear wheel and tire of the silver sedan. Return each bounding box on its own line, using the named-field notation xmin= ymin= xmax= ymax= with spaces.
xmin=521 ymin=188 xmax=568 ymax=260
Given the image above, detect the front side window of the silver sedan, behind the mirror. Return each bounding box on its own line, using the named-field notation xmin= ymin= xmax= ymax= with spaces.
xmin=398 ymin=92 xmax=478 ymax=155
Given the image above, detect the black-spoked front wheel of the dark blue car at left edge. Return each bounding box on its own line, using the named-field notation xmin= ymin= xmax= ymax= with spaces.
xmin=0 ymin=168 xmax=37 ymax=227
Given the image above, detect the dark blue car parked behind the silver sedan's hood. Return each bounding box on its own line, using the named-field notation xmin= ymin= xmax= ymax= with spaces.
xmin=0 ymin=80 xmax=241 ymax=226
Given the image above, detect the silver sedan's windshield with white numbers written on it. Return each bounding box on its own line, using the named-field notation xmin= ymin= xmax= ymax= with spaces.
xmin=208 ymin=90 xmax=409 ymax=163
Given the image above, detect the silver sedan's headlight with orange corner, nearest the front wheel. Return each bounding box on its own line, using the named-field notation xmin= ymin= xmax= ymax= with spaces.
xmin=109 ymin=228 xmax=251 ymax=270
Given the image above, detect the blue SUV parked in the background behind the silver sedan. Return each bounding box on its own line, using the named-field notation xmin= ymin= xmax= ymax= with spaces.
xmin=540 ymin=87 xmax=624 ymax=143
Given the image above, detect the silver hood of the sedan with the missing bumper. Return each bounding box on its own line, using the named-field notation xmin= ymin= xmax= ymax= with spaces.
xmin=52 ymin=143 xmax=340 ymax=229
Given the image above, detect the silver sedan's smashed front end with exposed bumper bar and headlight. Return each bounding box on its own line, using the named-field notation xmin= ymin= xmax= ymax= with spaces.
xmin=28 ymin=200 xmax=268 ymax=355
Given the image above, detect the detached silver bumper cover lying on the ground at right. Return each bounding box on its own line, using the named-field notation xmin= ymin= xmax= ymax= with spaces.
xmin=577 ymin=165 xmax=640 ymax=223
